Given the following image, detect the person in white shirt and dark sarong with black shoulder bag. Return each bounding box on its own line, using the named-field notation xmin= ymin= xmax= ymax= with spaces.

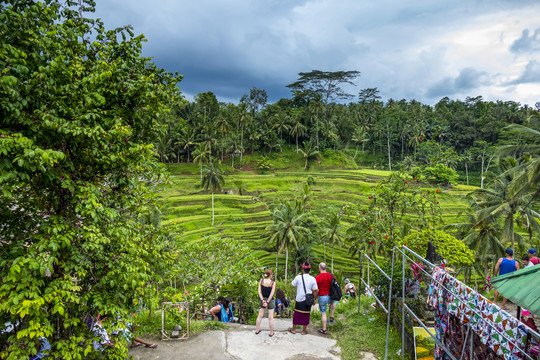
xmin=288 ymin=262 xmax=319 ymax=335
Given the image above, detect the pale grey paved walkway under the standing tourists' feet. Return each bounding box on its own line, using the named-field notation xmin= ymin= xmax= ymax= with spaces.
xmin=129 ymin=318 xmax=341 ymax=360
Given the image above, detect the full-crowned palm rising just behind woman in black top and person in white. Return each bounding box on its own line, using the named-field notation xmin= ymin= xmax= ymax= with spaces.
xmin=266 ymin=200 xmax=308 ymax=281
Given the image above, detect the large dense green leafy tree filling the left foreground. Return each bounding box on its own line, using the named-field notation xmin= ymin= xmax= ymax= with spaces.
xmin=0 ymin=0 xmax=180 ymax=359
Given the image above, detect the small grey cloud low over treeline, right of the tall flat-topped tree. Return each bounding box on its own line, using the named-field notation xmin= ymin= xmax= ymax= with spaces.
xmin=426 ymin=68 xmax=490 ymax=98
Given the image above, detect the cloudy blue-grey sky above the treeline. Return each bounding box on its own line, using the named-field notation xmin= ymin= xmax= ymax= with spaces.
xmin=96 ymin=0 xmax=540 ymax=106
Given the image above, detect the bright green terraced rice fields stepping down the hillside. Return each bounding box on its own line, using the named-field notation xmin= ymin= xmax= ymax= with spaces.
xmin=160 ymin=164 xmax=472 ymax=274
